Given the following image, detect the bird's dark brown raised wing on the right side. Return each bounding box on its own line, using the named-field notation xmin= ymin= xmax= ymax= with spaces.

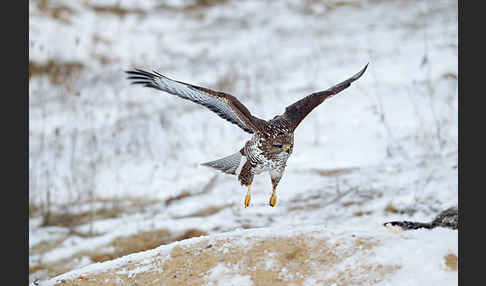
xmin=282 ymin=64 xmax=368 ymax=130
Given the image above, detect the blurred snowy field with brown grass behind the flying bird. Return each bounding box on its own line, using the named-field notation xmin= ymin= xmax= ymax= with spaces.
xmin=29 ymin=0 xmax=458 ymax=285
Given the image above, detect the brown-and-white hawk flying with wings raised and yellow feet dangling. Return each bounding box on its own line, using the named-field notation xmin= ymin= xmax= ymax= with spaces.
xmin=126 ymin=64 xmax=368 ymax=208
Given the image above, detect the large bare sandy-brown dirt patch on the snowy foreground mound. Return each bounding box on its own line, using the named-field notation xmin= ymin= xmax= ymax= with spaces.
xmin=50 ymin=233 xmax=399 ymax=286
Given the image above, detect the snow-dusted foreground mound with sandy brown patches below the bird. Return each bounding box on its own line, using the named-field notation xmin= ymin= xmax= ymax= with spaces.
xmin=40 ymin=226 xmax=458 ymax=286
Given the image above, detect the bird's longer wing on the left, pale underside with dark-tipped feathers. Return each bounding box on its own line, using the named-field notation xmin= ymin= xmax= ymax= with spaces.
xmin=126 ymin=69 xmax=262 ymax=133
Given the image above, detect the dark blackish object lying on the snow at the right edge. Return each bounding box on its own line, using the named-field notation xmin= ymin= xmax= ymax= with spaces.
xmin=383 ymin=207 xmax=459 ymax=230
